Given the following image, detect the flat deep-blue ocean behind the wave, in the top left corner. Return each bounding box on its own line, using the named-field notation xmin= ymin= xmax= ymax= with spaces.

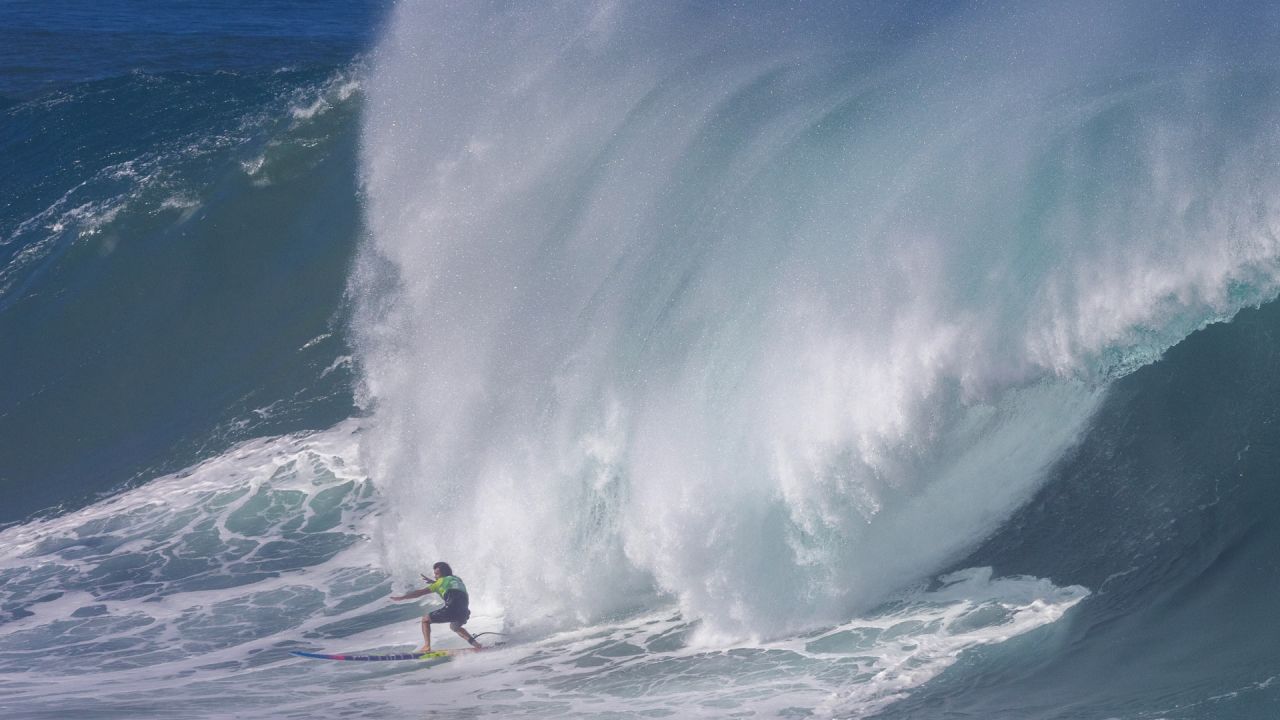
xmin=0 ymin=0 xmax=389 ymax=102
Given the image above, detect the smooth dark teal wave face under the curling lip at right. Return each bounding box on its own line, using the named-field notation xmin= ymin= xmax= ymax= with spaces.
xmin=892 ymin=293 xmax=1280 ymax=719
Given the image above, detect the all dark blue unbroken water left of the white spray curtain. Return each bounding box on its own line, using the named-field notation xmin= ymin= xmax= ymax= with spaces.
xmin=0 ymin=1 xmax=388 ymax=521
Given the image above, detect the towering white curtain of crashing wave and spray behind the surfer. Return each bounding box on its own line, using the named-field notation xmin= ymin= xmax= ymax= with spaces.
xmin=353 ymin=3 xmax=1280 ymax=637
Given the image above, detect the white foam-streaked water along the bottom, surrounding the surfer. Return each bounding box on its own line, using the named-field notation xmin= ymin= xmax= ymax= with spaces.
xmin=0 ymin=420 xmax=1088 ymax=717
